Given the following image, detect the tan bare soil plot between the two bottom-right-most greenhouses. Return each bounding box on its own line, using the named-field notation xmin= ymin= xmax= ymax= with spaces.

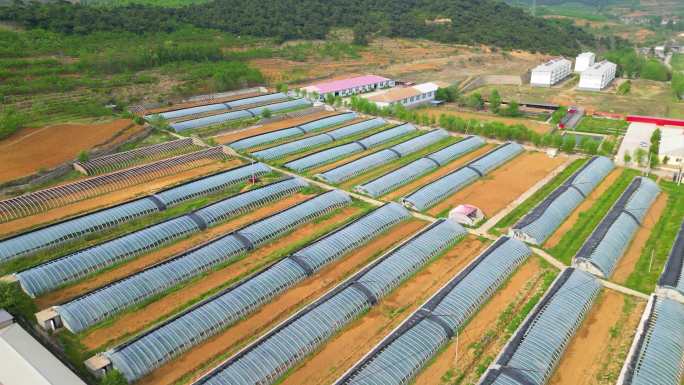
xmin=549 ymin=289 xmax=646 ymax=385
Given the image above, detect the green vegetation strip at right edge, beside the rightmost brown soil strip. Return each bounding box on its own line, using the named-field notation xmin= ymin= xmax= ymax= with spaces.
xmin=625 ymin=181 xmax=684 ymax=293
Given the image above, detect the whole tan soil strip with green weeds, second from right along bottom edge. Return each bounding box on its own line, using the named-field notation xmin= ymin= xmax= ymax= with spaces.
xmin=415 ymin=257 xmax=556 ymax=385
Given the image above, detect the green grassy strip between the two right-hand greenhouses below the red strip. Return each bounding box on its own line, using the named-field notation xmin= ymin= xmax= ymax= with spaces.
xmin=549 ymin=169 xmax=639 ymax=265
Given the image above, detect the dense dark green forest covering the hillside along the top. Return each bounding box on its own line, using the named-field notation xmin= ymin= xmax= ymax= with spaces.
xmin=0 ymin=0 xmax=597 ymax=54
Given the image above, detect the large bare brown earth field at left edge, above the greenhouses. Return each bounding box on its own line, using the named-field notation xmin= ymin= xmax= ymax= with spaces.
xmin=0 ymin=119 xmax=142 ymax=182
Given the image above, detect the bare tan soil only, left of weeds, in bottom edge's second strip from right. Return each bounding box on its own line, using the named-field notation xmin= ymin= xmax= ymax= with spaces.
xmin=414 ymin=258 xmax=543 ymax=385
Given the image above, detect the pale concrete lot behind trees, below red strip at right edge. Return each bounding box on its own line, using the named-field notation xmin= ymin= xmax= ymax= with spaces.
xmin=616 ymin=122 xmax=684 ymax=167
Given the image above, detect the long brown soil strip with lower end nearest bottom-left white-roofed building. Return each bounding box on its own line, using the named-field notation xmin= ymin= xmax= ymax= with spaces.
xmin=81 ymin=207 xmax=361 ymax=349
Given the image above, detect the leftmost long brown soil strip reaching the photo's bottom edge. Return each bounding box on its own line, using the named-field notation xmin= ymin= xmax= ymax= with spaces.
xmin=140 ymin=219 xmax=425 ymax=385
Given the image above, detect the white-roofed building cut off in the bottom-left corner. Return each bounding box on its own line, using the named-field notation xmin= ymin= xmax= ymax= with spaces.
xmin=0 ymin=309 xmax=85 ymax=385
